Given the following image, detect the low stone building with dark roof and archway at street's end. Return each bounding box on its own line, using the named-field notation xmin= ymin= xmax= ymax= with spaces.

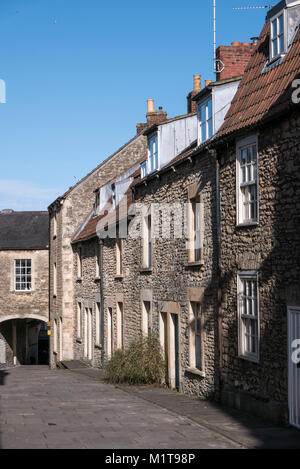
xmin=0 ymin=210 xmax=49 ymax=368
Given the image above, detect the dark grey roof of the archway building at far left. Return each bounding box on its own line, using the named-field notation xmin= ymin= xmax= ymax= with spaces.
xmin=0 ymin=210 xmax=49 ymax=250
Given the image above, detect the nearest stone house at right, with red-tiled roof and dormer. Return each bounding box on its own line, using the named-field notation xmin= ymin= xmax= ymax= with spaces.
xmin=213 ymin=1 xmax=300 ymax=427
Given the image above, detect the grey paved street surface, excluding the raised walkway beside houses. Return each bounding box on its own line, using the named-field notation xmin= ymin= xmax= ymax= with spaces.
xmin=0 ymin=366 xmax=239 ymax=449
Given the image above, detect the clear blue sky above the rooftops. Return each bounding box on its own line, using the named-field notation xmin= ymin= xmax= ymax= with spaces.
xmin=0 ymin=0 xmax=268 ymax=210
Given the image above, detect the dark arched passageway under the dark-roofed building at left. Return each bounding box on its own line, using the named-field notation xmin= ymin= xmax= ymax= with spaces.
xmin=0 ymin=317 xmax=49 ymax=368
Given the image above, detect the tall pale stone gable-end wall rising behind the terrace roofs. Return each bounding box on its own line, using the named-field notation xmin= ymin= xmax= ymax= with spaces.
xmin=50 ymin=135 xmax=147 ymax=367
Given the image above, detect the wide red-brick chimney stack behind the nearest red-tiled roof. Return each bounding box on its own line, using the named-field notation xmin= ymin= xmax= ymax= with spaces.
xmin=216 ymin=42 xmax=255 ymax=81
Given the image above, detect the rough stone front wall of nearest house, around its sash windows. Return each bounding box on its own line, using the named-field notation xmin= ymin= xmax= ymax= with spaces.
xmin=218 ymin=114 xmax=300 ymax=422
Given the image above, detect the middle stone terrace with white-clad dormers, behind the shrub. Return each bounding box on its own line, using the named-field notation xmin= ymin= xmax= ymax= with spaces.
xmin=69 ymin=64 xmax=246 ymax=397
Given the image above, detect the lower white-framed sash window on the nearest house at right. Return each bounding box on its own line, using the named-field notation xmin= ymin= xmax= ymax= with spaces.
xmin=238 ymin=272 xmax=260 ymax=362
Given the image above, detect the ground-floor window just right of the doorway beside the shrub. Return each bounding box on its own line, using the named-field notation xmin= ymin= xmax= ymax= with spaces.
xmin=189 ymin=302 xmax=205 ymax=372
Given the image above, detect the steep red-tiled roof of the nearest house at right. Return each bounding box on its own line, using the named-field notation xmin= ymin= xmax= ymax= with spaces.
xmin=216 ymin=22 xmax=300 ymax=139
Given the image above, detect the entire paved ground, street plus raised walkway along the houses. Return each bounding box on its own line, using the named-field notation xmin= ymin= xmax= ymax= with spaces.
xmin=0 ymin=363 xmax=300 ymax=449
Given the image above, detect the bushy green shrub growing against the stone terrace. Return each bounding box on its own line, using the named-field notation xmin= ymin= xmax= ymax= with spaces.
xmin=104 ymin=337 xmax=165 ymax=385
